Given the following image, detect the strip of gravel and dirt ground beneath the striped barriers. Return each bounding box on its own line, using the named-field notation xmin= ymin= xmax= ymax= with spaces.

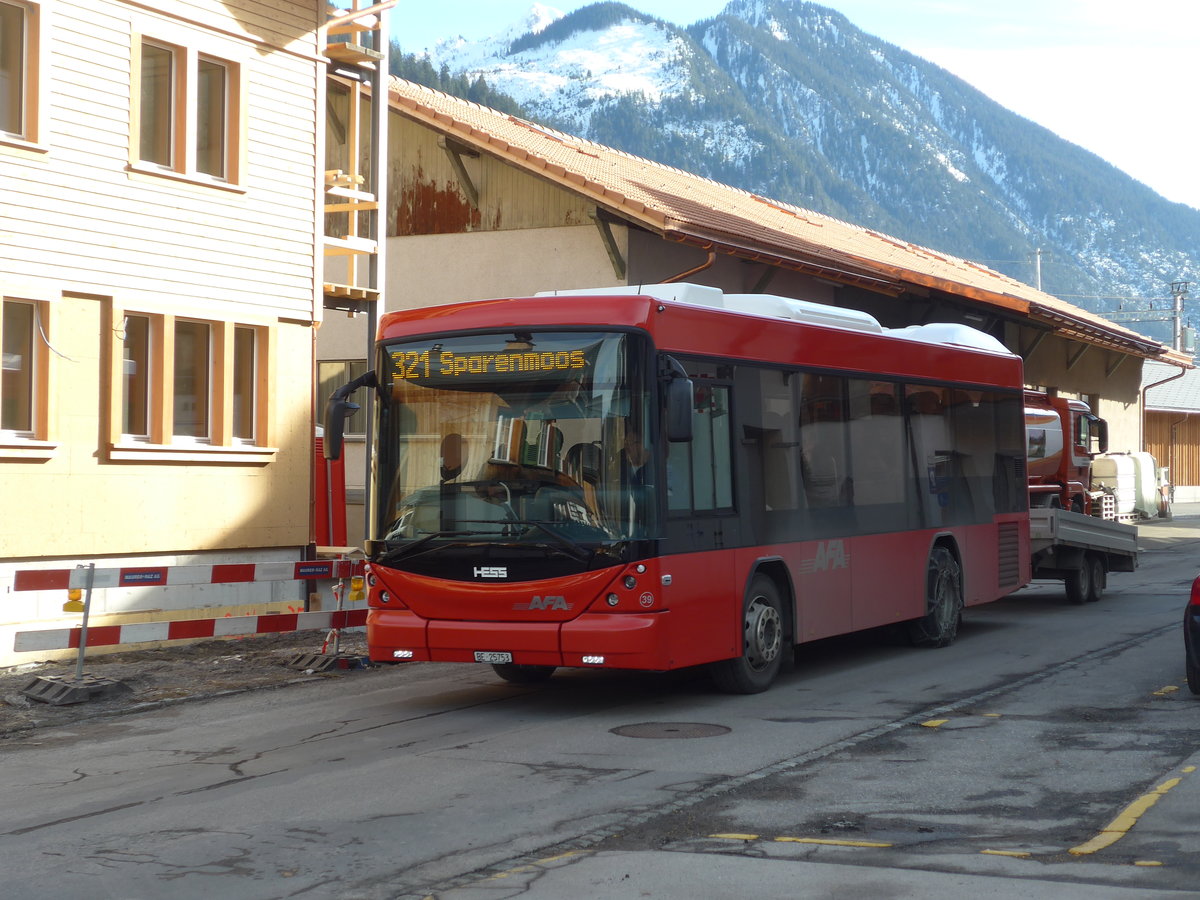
xmin=0 ymin=631 xmax=366 ymax=740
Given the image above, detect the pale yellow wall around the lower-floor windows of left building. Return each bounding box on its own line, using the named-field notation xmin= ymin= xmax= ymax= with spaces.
xmin=0 ymin=298 xmax=312 ymax=559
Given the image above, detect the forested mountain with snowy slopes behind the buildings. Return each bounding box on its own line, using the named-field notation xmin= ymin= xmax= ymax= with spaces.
xmin=394 ymin=0 xmax=1200 ymax=340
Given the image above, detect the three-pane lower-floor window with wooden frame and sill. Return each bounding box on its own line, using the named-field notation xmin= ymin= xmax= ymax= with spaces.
xmin=109 ymin=308 xmax=275 ymax=462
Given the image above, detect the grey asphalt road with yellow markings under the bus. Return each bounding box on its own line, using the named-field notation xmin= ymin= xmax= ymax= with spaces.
xmin=0 ymin=508 xmax=1200 ymax=900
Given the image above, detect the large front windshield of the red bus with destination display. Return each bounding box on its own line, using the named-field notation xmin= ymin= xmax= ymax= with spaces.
xmin=374 ymin=331 xmax=658 ymax=568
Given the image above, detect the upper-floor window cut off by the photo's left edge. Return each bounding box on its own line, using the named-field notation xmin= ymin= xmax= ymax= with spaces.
xmin=0 ymin=0 xmax=42 ymax=143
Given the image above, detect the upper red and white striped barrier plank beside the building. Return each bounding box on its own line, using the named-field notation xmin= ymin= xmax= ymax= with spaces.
xmin=12 ymin=559 xmax=362 ymax=595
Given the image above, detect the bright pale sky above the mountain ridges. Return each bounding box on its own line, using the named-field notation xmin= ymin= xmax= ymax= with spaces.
xmin=391 ymin=0 xmax=1200 ymax=209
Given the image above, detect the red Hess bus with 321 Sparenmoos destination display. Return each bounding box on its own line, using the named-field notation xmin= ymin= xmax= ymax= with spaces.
xmin=325 ymin=284 xmax=1030 ymax=692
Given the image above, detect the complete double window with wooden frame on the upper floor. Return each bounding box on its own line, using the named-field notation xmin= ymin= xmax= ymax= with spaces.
xmin=130 ymin=35 xmax=245 ymax=185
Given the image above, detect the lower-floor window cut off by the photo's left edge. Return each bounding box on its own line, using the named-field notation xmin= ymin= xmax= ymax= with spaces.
xmin=0 ymin=296 xmax=53 ymax=456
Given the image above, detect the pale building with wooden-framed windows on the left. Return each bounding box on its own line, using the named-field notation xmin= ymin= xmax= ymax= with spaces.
xmin=0 ymin=0 xmax=367 ymax=665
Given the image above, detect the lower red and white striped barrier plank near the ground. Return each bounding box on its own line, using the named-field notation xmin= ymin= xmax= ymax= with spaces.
xmin=13 ymin=610 xmax=367 ymax=653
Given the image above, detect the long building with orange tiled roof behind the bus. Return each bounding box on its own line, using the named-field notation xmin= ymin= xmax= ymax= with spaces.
xmin=318 ymin=79 xmax=1189 ymax=540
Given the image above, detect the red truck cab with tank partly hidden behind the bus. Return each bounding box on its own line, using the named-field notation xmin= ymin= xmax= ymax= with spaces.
xmin=1025 ymin=390 xmax=1109 ymax=515
